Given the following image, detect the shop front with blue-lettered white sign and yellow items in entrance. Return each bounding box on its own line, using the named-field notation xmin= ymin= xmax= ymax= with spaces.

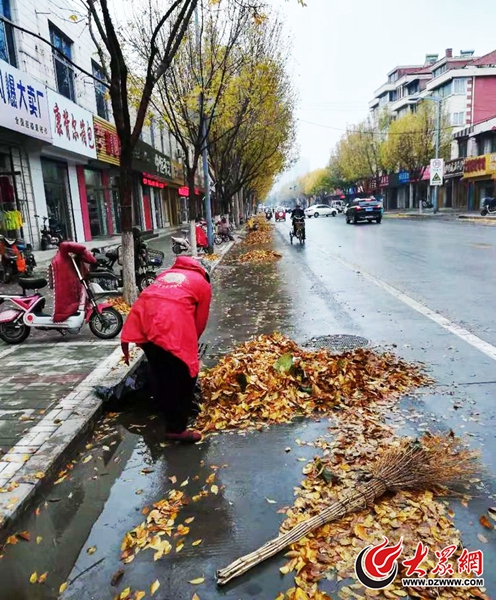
xmin=0 ymin=54 xmax=52 ymax=247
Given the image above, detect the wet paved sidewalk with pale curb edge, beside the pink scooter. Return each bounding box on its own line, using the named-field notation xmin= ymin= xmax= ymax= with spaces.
xmin=0 ymin=237 xmax=232 ymax=540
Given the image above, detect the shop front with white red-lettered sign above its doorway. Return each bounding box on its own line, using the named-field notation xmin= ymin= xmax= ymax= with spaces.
xmin=41 ymin=90 xmax=96 ymax=241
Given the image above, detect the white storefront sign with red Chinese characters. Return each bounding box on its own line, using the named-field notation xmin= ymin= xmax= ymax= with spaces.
xmin=47 ymin=89 xmax=96 ymax=158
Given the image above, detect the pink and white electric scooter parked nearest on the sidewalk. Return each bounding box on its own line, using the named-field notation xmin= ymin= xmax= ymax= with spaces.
xmin=0 ymin=255 xmax=123 ymax=344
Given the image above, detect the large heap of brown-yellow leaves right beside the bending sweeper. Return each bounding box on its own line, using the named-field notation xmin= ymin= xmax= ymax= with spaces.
xmin=197 ymin=333 xmax=430 ymax=431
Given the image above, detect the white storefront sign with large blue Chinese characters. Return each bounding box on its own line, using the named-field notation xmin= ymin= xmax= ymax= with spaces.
xmin=0 ymin=60 xmax=52 ymax=142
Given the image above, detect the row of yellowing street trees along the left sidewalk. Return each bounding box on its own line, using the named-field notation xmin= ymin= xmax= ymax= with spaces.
xmin=81 ymin=0 xmax=304 ymax=303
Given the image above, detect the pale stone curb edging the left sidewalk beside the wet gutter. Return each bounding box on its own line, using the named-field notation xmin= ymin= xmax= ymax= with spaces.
xmin=0 ymin=236 xmax=235 ymax=542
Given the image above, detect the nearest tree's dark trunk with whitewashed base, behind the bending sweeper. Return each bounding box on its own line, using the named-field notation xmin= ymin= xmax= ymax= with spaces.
xmin=119 ymin=155 xmax=137 ymax=305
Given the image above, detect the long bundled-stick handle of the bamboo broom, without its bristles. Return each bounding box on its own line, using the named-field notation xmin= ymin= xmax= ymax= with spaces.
xmin=217 ymin=482 xmax=385 ymax=585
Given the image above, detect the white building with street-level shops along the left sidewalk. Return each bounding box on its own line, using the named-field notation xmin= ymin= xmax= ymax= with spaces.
xmin=0 ymin=0 xmax=192 ymax=248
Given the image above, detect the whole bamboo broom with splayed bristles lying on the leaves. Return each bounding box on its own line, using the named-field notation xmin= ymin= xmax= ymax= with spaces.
xmin=217 ymin=434 xmax=480 ymax=585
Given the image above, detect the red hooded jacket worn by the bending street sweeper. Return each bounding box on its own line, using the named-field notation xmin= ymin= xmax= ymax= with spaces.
xmin=121 ymin=256 xmax=212 ymax=377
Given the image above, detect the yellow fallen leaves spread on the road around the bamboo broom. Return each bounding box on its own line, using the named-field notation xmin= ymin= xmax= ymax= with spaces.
xmin=276 ymin=404 xmax=489 ymax=600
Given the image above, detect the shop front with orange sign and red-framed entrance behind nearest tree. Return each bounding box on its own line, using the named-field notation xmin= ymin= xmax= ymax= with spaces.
xmin=78 ymin=116 xmax=121 ymax=241
